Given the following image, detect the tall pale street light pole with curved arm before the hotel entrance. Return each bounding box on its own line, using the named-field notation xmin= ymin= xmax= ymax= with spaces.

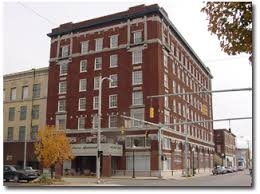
xmin=96 ymin=76 xmax=113 ymax=183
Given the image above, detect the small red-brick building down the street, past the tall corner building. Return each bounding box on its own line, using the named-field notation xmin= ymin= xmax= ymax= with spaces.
xmin=214 ymin=129 xmax=236 ymax=166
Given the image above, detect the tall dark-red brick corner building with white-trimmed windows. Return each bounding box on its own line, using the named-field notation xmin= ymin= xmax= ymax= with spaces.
xmin=46 ymin=4 xmax=214 ymax=176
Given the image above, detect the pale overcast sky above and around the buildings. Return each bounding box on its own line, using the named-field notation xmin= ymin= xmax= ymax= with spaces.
xmin=2 ymin=0 xmax=252 ymax=147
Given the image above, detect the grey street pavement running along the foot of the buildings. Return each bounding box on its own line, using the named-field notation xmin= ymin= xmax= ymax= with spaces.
xmin=4 ymin=170 xmax=251 ymax=187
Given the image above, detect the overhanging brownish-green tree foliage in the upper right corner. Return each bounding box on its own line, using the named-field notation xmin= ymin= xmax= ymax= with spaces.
xmin=201 ymin=2 xmax=252 ymax=62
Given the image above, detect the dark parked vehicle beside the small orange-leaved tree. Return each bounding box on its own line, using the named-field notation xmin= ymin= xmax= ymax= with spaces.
xmin=4 ymin=165 xmax=38 ymax=182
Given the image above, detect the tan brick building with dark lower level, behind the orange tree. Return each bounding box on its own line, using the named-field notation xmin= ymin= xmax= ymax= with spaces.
xmin=3 ymin=68 xmax=48 ymax=168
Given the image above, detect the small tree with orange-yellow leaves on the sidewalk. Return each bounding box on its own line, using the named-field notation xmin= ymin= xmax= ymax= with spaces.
xmin=34 ymin=126 xmax=73 ymax=178
